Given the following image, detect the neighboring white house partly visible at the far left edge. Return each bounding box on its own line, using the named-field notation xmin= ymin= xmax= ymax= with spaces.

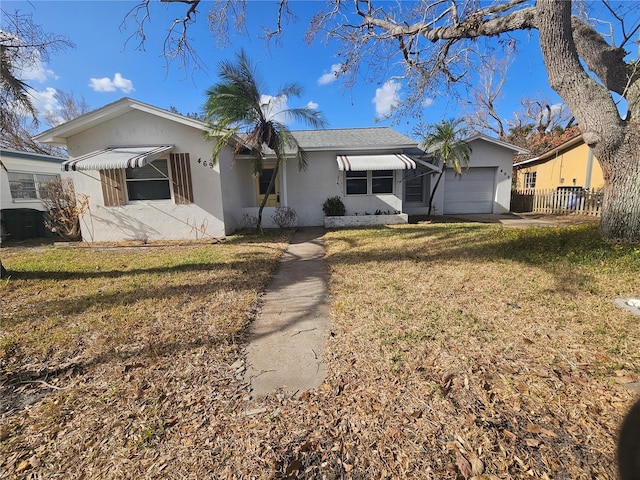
xmin=0 ymin=149 xmax=67 ymax=240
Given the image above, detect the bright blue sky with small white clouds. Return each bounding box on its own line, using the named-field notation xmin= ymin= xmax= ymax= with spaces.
xmin=2 ymin=0 xmax=559 ymax=139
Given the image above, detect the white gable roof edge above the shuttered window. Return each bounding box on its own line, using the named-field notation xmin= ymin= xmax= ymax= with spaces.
xmin=33 ymin=97 xmax=207 ymax=145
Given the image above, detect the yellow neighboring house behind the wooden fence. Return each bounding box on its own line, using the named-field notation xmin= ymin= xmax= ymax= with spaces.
xmin=513 ymin=134 xmax=604 ymax=191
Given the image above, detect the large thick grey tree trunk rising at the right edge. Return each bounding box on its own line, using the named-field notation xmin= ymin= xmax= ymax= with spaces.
xmin=536 ymin=0 xmax=640 ymax=242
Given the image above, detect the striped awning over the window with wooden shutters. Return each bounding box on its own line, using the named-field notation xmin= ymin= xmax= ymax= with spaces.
xmin=62 ymin=145 xmax=174 ymax=172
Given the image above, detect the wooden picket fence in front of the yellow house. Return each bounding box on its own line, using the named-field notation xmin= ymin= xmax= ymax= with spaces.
xmin=511 ymin=189 xmax=603 ymax=217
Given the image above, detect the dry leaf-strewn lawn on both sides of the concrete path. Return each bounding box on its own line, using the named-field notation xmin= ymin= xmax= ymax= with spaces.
xmin=0 ymin=223 xmax=640 ymax=479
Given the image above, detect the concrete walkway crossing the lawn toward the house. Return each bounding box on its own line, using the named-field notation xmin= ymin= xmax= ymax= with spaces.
xmin=245 ymin=228 xmax=329 ymax=398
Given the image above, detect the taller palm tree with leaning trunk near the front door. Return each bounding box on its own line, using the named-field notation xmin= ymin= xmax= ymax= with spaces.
xmin=204 ymin=50 xmax=326 ymax=229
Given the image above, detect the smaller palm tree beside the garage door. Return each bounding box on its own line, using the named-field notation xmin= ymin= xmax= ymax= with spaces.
xmin=420 ymin=118 xmax=471 ymax=216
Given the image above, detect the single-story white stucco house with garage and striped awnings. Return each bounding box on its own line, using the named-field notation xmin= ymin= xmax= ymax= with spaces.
xmin=35 ymin=98 xmax=519 ymax=241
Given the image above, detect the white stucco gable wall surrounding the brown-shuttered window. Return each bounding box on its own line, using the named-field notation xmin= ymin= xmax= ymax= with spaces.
xmin=67 ymin=110 xmax=230 ymax=242
